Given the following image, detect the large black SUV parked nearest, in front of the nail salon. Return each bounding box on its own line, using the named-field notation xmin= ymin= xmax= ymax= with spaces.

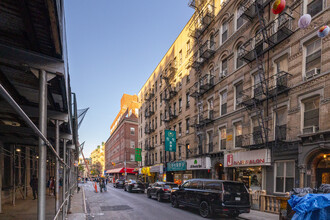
xmin=171 ymin=179 xmax=250 ymax=218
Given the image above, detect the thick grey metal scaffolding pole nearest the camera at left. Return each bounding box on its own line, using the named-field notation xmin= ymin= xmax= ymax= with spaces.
xmin=38 ymin=70 xmax=47 ymax=220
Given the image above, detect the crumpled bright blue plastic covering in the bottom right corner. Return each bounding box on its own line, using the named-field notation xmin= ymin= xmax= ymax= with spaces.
xmin=288 ymin=194 xmax=330 ymax=220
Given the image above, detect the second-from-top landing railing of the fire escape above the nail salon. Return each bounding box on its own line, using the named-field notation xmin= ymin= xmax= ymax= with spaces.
xmin=239 ymin=13 xmax=293 ymax=63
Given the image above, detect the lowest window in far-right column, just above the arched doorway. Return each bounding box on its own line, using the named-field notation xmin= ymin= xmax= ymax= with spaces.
xmin=303 ymin=97 xmax=320 ymax=132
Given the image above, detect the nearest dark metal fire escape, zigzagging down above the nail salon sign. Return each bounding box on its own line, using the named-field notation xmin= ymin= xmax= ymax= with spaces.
xmin=236 ymin=0 xmax=293 ymax=148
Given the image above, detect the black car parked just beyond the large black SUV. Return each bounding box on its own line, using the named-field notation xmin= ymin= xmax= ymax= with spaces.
xmin=147 ymin=182 xmax=178 ymax=202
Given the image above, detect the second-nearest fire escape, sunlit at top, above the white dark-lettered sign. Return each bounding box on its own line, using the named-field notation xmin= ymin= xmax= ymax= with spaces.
xmin=189 ymin=0 xmax=216 ymax=154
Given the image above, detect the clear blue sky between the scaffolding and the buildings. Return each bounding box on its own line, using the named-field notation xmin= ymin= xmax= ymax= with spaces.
xmin=64 ymin=0 xmax=194 ymax=157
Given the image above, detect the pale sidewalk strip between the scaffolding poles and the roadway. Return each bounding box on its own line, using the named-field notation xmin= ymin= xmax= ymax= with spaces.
xmin=67 ymin=185 xmax=86 ymax=220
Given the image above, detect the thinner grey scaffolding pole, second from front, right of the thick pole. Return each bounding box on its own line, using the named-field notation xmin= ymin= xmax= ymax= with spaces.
xmin=55 ymin=120 xmax=60 ymax=218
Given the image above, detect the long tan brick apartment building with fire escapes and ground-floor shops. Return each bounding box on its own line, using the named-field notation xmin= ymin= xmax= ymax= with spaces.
xmin=139 ymin=0 xmax=330 ymax=203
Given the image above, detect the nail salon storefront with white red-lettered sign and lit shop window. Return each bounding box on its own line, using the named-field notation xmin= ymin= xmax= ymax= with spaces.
xmin=224 ymin=149 xmax=271 ymax=191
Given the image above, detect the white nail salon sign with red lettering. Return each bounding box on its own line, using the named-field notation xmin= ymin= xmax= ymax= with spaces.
xmin=224 ymin=149 xmax=271 ymax=167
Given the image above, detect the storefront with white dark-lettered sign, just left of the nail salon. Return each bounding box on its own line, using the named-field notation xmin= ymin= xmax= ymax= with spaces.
xmin=187 ymin=157 xmax=212 ymax=179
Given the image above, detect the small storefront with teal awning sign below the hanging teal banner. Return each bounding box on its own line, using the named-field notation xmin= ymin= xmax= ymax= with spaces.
xmin=166 ymin=161 xmax=192 ymax=185
